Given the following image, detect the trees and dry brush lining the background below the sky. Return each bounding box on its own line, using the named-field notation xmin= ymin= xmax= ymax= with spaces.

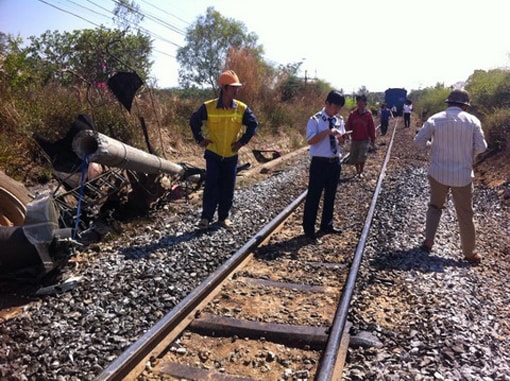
xmin=0 ymin=0 xmax=510 ymax=178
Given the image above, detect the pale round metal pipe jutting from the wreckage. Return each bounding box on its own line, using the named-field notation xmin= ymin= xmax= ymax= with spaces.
xmin=73 ymin=130 xmax=184 ymax=175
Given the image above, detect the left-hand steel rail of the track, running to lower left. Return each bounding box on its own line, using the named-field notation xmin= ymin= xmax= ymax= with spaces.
xmin=95 ymin=191 xmax=307 ymax=381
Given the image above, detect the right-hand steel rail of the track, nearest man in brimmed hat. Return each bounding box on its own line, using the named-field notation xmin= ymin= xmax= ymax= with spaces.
xmin=315 ymin=121 xmax=397 ymax=381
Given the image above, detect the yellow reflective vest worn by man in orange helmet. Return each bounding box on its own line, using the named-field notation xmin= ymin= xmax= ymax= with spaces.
xmin=202 ymin=99 xmax=248 ymax=157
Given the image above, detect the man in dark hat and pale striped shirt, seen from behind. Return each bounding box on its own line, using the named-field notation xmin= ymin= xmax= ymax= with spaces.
xmin=414 ymin=90 xmax=487 ymax=263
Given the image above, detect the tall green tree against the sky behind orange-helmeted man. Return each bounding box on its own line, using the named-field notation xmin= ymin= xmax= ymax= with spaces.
xmin=177 ymin=7 xmax=263 ymax=89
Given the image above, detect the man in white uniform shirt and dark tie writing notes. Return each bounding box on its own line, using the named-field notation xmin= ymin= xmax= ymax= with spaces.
xmin=303 ymin=90 xmax=345 ymax=243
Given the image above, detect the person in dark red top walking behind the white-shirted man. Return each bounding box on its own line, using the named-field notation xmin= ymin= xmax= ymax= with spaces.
xmin=345 ymin=95 xmax=375 ymax=177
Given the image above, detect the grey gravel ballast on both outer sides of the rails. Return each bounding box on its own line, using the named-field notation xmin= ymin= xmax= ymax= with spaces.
xmin=0 ymin=123 xmax=510 ymax=380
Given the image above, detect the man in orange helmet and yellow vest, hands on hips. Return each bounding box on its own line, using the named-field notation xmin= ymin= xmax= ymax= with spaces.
xmin=190 ymin=70 xmax=259 ymax=229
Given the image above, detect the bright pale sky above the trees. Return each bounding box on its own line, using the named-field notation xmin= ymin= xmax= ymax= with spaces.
xmin=0 ymin=0 xmax=510 ymax=93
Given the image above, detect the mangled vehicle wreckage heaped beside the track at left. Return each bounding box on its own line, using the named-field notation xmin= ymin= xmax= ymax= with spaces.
xmin=0 ymin=73 xmax=281 ymax=279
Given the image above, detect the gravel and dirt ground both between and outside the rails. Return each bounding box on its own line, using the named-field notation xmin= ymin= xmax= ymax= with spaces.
xmin=0 ymin=116 xmax=510 ymax=381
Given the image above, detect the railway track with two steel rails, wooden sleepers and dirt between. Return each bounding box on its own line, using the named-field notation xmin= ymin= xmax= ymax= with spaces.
xmin=97 ymin=121 xmax=397 ymax=380
